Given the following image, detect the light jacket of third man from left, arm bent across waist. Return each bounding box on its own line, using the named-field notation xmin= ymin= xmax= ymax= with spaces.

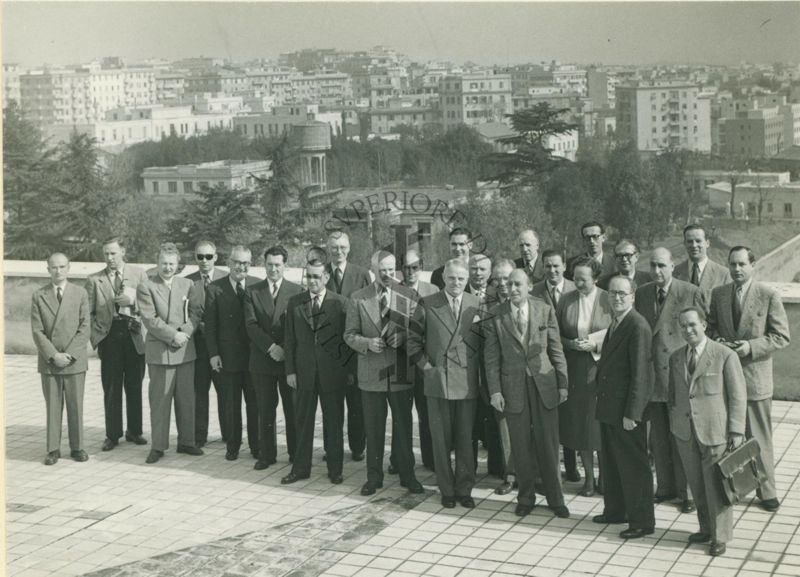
xmin=136 ymin=274 xmax=200 ymax=365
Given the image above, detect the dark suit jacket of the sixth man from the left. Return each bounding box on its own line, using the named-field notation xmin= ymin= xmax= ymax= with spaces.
xmin=244 ymin=279 xmax=303 ymax=375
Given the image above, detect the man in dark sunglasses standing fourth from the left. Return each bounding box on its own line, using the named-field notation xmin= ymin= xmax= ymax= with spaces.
xmin=186 ymin=240 xmax=230 ymax=447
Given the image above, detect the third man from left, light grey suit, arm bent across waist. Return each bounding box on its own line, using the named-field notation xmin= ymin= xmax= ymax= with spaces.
xmin=136 ymin=242 xmax=203 ymax=463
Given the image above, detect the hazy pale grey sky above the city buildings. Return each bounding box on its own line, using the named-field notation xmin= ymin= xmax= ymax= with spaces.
xmin=0 ymin=0 xmax=800 ymax=67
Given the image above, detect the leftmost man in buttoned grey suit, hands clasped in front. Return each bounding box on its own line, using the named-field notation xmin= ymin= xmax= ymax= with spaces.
xmin=31 ymin=252 xmax=89 ymax=465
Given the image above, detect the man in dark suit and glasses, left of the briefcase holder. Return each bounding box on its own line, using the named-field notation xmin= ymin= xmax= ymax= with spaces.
xmin=592 ymin=276 xmax=655 ymax=539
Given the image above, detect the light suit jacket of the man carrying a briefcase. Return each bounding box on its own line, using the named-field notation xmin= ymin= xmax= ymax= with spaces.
xmin=669 ymin=339 xmax=747 ymax=446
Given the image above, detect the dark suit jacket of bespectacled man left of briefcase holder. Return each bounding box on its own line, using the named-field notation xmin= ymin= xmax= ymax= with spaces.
xmin=595 ymin=310 xmax=653 ymax=426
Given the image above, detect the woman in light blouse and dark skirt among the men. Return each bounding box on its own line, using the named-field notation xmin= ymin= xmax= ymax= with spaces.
xmin=557 ymin=256 xmax=611 ymax=497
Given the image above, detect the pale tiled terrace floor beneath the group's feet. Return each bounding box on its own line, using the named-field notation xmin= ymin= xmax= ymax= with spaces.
xmin=5 ymin=356 xmax=800 ymax=577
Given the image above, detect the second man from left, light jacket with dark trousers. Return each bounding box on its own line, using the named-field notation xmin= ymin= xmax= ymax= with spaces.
xmin=86 ymin=237 xmax=147 ymax=451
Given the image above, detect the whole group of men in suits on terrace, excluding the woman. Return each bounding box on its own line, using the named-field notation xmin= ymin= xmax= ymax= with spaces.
xmin=31 ymin=222 xmax=790 ymax=554
